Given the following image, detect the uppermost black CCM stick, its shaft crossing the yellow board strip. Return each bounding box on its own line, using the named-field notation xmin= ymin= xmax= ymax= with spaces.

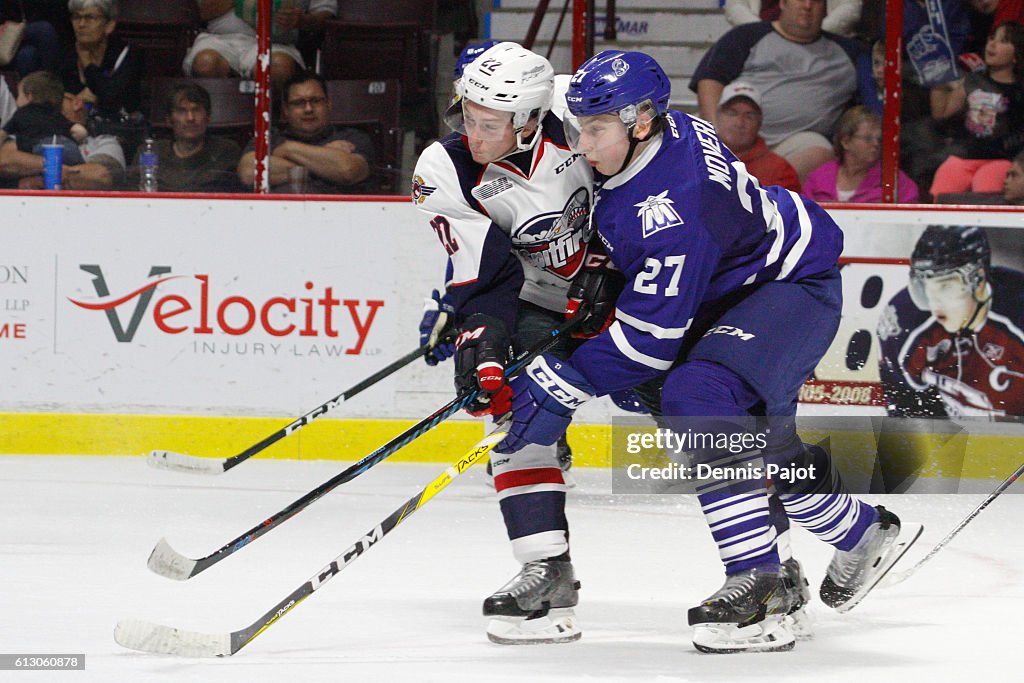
xmin=146 ymin=344 xmax=444 ymax=474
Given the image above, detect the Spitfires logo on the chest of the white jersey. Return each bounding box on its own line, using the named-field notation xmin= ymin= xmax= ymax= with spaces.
xmin=512 ymin=187 xmax=590 ymax=280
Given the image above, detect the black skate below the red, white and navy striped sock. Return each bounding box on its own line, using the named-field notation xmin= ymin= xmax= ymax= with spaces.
xmin=483 ymin=559 xmax=583 ymax=645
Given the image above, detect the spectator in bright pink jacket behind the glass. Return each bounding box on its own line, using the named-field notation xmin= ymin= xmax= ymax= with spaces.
xmin=803 ymin=104 xmax=918 ymax=204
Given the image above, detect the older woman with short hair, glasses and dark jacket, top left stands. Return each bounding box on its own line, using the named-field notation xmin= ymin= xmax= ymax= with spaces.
xmin=60 ymin=0 xmax=143 ymax=120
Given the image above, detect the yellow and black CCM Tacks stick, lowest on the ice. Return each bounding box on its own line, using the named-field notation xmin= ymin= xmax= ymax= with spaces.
xmin=114 ymin=431 xmax=507 ymax=657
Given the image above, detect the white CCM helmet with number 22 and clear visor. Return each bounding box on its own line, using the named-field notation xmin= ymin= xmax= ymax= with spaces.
xmin=444 ymin=43 xmax=555 ymax=151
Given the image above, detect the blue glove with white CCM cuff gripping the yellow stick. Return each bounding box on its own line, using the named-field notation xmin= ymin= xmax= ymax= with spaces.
xmin=495 ymin=353 xmax=595 ymax=453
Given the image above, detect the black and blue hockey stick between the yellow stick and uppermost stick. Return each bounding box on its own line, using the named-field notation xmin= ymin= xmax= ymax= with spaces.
xmin=146 ymin=311 xmax=587 ymax=581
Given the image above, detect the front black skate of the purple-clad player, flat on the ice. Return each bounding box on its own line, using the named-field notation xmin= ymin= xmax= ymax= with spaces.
xmin=687 ymin=565 xmax=797 ymax=653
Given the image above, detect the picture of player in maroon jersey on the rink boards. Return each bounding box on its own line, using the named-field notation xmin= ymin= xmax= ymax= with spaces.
xmin=876 ymin=224 xmax=1024 ymax=419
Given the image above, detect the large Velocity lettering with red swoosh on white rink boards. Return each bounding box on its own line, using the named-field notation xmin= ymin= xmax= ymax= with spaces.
xmin=68 ymin=264 xmax=384 ymax=355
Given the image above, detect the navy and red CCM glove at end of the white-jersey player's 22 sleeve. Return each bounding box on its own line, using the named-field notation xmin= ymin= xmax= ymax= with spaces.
xmin=455 ymin=313 xmax=512 ymax=416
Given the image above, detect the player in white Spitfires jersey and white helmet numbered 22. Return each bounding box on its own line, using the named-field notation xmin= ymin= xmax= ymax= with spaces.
xmin=412 ymin=43 xmax=614 ymax=643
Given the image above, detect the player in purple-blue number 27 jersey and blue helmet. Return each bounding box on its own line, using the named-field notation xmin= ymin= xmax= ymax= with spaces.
xmin=498 ymin=51 xmax=925 ymax=651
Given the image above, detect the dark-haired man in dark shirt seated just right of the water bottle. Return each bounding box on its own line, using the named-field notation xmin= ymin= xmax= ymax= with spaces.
xmin=128 ymin=83 xmax=245 ymax=193
